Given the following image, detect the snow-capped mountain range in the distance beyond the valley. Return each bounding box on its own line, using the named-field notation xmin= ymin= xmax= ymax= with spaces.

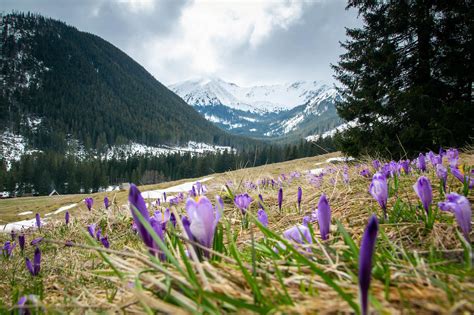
xmin=169 ymin=77 xmax=341 ymax=137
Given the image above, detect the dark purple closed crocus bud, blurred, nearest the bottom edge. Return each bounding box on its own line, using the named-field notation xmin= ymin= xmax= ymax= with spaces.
xmin=359 ymin=215 xmax=379 ymax=315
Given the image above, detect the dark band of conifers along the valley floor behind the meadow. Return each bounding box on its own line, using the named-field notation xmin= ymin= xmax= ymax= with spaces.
xmin=0 ymin=138 xmax=335 ymax=196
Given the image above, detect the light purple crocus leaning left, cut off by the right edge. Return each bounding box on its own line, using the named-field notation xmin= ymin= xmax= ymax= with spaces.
xmin=438 ymin=193 xmax=472 ymax=243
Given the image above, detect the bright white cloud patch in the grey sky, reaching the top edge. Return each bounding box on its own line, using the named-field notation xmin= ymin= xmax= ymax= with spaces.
xmin=136 ymin=1 xmax=305 ymax=83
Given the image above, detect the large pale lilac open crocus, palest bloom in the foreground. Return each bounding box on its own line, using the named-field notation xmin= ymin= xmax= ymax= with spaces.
xmin=186 ymin=196 xmax=221 ymax=257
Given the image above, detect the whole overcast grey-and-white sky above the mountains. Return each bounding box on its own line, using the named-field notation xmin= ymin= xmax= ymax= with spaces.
xmin=1 ymin=0 xmax=360 ymax=85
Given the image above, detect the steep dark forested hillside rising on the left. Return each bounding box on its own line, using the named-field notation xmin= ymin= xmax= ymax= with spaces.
xmin=0 ymin=13 xmax=252 ymax=151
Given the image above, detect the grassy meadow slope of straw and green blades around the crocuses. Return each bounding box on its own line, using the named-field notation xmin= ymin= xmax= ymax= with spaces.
xmin=0 ymin=150 xmax=474 ymax=314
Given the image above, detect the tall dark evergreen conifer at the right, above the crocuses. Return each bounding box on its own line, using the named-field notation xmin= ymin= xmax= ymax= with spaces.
xmin=333 ymin=0 xmax=474 ymax=157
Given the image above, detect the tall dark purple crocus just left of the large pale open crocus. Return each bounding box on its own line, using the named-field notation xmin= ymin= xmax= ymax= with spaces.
xmin=128 ymin=184 xmax=166 ymax=259
